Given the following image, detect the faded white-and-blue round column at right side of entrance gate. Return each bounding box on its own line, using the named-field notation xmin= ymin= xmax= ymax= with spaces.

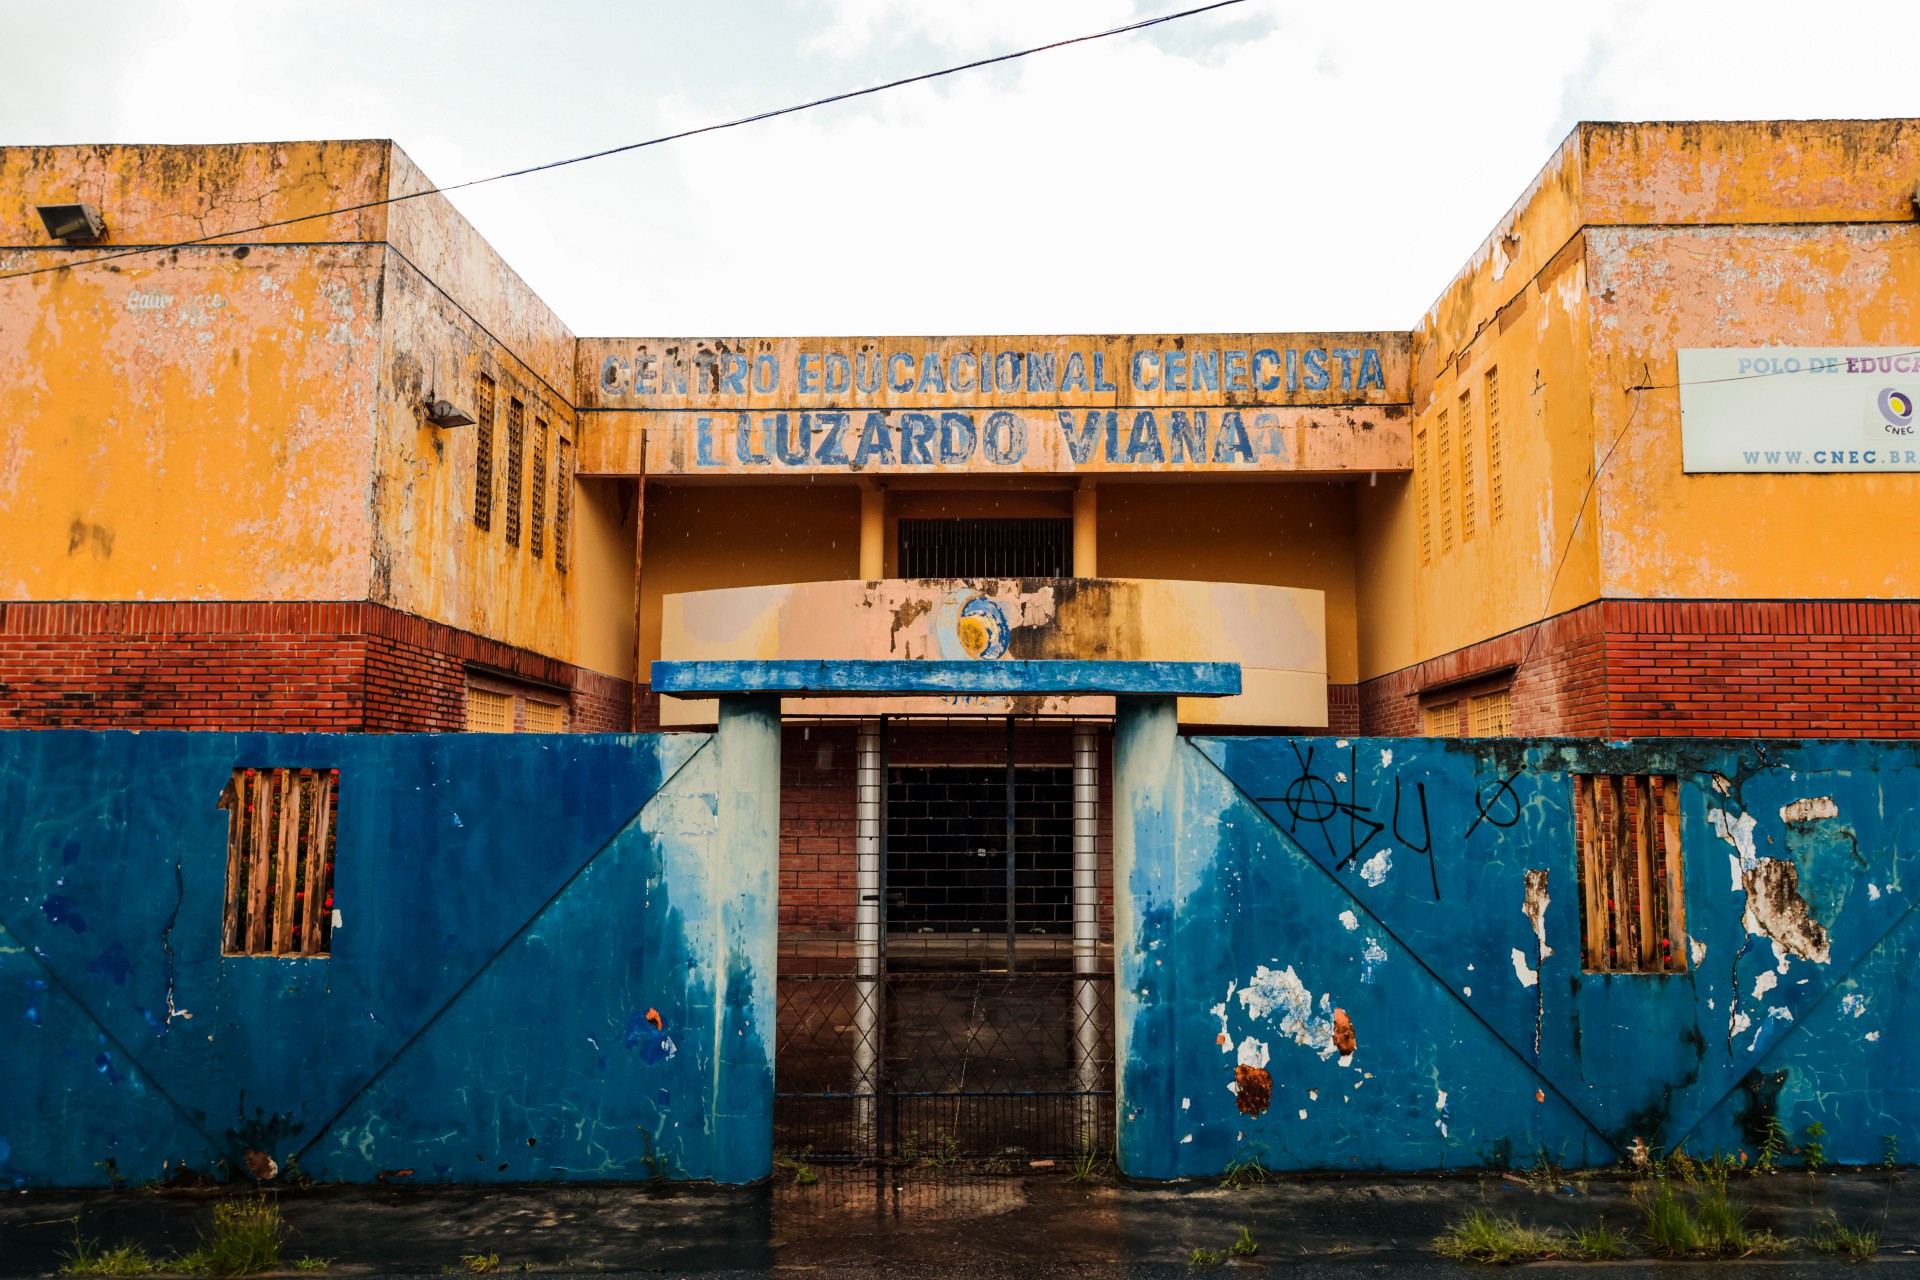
xmin=1114 ymin=697 xmax=1179 ymax=1178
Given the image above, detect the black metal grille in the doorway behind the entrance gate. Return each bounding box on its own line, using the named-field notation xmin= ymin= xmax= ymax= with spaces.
xmin=887 ymin=766 xmax=1073 ymax=935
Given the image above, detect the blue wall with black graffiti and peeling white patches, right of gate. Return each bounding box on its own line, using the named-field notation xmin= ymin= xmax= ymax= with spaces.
xmin=1116 ymin=700 xmax=1920 ymax=1178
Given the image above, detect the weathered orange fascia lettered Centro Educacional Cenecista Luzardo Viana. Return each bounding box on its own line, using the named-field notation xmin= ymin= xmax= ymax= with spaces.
xmin=578 ymin=334 xmax=1411 ymax=478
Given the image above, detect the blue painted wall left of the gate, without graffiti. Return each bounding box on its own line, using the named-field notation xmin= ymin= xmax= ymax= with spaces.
xmin=0 ymin=731 xmax=778 ymax=1186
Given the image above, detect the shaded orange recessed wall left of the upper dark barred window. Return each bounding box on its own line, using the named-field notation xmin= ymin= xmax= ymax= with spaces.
xmin=639 ymin=484 xmax=860 ymax=664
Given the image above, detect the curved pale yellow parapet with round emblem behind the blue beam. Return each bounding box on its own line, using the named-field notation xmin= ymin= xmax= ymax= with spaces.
xmin=660 ymin=578 xmax=1327 ymax=727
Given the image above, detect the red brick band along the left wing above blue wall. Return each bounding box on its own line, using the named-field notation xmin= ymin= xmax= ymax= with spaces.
xmin=0 ymin=603 xmax=632 ymax=733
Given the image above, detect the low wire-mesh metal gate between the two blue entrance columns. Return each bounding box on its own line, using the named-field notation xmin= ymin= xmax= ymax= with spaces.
xmin=774 ymin=969 xmax=1114 ymax=1165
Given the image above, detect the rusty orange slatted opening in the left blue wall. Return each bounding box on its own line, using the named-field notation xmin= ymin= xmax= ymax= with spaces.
xmin=219 ymin=770 xmax=340 ymax=956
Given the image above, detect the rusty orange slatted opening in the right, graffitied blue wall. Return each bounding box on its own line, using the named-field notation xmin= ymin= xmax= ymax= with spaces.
xmin=1572 ymin=773 xmax=1686 ymax=973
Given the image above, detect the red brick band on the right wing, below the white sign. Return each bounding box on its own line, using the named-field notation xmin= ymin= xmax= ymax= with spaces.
xmin=1359 ymin=601 xmax=1920 ymax=737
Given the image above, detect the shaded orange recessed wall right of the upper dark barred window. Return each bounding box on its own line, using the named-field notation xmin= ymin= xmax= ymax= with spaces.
xmin=1100 ymin=480 xmax=1365 ymax=685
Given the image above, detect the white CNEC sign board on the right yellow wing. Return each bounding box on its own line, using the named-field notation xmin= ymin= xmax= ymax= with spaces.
xmin=1680 ymin=344 xmax=1920 ymax=472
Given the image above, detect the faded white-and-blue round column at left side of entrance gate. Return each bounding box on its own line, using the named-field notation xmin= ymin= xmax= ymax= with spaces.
xmin=707 ymin=695 xmax=780 ymax=1182
